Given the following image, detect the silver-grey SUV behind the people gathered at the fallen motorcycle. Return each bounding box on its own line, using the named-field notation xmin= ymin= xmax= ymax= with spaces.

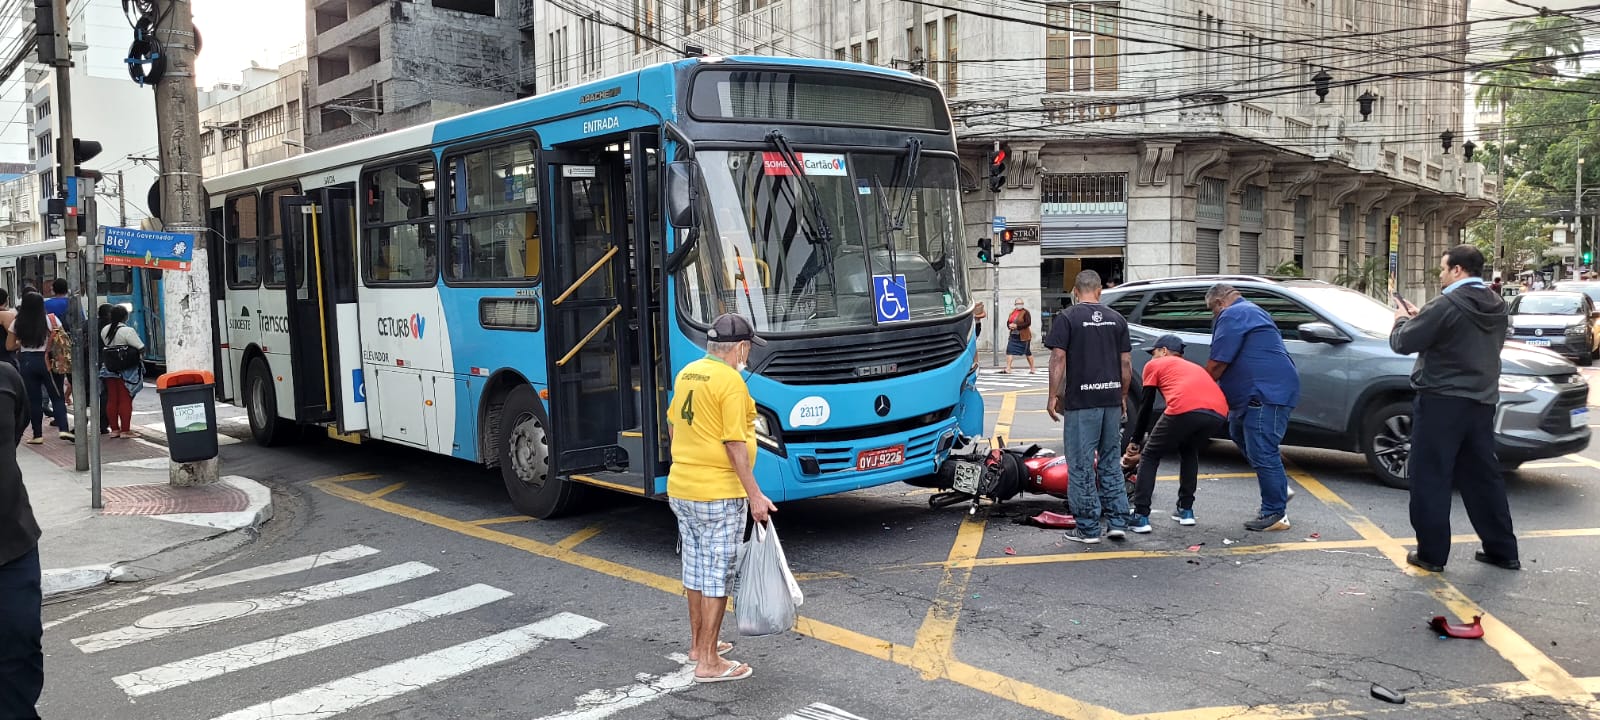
xmin=1102 ymin=275 xmax=1589 ymax=488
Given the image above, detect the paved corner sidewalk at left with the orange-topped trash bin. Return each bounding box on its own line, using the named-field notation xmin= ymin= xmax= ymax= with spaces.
xmin=25 ymin=389 xmax=272 ymax=597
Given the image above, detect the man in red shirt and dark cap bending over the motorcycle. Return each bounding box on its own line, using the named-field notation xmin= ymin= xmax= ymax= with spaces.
xmin=1128 ymin=334 xmax=1227 ymax=533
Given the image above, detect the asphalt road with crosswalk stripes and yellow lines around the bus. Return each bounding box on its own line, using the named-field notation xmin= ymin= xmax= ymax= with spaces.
xmin=42 ymin=376 xmax=1600 ymax=720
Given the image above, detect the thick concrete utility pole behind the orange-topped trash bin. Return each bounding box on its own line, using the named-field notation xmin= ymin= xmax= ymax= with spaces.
xmin=155 ymin=0 xmax=218 ymax=486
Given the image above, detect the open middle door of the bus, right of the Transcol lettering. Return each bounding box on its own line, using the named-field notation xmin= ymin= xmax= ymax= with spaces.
xmin=278 ymin=186 xmax=366 ymax=432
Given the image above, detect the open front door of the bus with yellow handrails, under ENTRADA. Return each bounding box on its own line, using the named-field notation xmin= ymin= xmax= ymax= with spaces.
xmin=542 ymin=139 xmax=653 ymax=493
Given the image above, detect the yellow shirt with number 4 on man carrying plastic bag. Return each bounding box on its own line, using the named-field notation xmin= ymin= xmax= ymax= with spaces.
xmin=667 ymin=355 xmax=755 ymax=502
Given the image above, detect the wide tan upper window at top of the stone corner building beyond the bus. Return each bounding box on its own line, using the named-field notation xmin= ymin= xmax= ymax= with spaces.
xmin=1045 ymin=3 xmax=1120 ymax=93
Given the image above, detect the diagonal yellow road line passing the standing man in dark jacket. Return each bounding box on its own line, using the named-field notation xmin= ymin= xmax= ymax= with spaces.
xmin=1290 ymin=464 xmax=1600 ymax=706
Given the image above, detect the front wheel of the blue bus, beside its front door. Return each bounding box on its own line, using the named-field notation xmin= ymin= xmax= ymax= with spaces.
xmin=499 ymin=386 xmax=582 ymax=520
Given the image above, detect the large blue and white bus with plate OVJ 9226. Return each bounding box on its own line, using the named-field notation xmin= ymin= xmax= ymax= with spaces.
xmin=206 ymin=58 xmax=984 ymax=518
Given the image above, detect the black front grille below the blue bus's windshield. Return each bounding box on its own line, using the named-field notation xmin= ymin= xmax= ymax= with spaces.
xmin=760 ymin=333 xmax=966 ymax=386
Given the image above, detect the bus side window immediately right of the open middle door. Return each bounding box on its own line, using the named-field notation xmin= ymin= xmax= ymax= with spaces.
xmin=362 ymin=157 xmax=438 ymax=286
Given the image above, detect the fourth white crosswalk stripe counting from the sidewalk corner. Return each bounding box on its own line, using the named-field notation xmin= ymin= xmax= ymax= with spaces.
xmin=214 ymin=613 xmax=605 ymax=720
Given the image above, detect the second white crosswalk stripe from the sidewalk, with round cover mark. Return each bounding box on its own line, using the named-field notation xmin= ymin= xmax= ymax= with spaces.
xmin=72 ymin=562 xmax=438 ymax=653
